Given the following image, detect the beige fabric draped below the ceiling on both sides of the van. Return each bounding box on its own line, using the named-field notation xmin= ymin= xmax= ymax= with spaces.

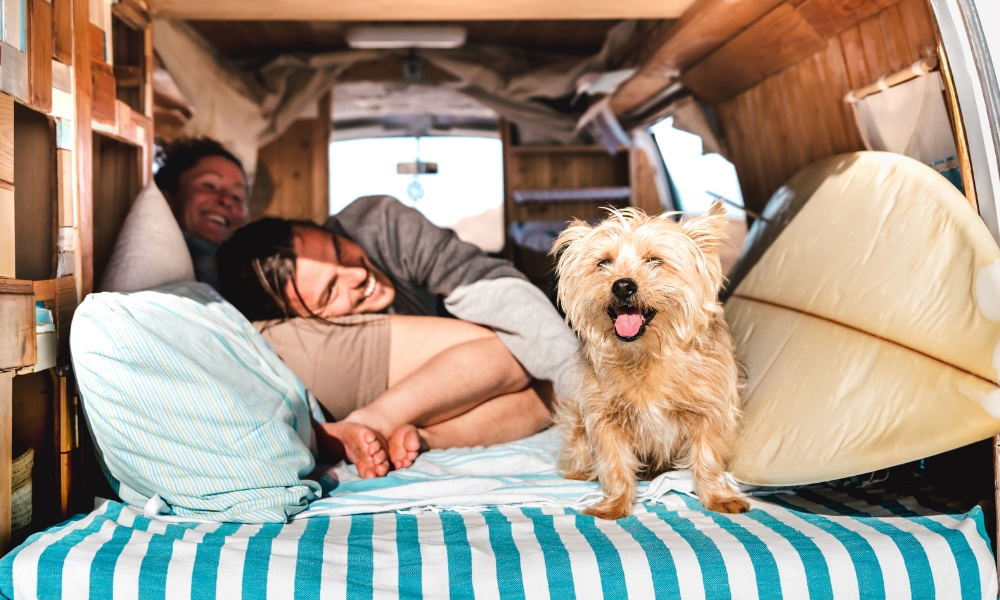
xmin=153 ymin=19 xmax=636 ymax=172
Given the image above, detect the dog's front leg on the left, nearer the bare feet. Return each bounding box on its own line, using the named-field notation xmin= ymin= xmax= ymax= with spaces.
xmin=583 ymin=421 xmax=639 ymax=520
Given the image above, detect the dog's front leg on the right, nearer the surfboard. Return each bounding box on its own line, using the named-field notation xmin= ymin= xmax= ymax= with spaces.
xmin=691 ymin=425 xmax=750 ymax=514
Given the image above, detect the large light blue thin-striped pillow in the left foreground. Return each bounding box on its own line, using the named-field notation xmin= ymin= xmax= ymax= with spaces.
xmin=70 ymin=283 xmax=320 ymax=523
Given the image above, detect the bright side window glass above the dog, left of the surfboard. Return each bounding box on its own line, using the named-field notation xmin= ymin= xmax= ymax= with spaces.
xmin=649 ymin=117 xmax=746 ymax=219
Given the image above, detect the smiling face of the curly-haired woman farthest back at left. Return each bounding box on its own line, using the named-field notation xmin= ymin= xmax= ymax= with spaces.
xmin=173 ymin=156 xmax=247 ymax=244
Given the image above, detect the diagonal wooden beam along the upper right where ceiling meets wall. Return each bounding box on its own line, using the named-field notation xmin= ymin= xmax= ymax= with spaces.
xmin=611 ymin=0 xmax=785 ymax=115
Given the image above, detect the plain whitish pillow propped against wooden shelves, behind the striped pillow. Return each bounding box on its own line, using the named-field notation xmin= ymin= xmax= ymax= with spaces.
xmin=98 ymin=180 xmax=195 ymax=292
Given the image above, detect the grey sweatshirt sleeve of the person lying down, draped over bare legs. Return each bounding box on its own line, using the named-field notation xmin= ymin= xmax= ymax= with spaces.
xmin=326 ymin=196 xmax=579 ymax=395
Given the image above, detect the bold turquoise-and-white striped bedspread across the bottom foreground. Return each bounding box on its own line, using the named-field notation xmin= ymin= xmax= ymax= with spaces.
xmin=0 ymin=487 xmax=997 ymax=599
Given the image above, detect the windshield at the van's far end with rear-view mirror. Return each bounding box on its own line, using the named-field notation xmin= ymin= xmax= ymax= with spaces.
xmin=330 ymin=137 xmax=504 ymax=252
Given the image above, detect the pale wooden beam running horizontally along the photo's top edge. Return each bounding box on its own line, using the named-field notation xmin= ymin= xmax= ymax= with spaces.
xmin=151 ymin=0 xmax=692 ymax=21
